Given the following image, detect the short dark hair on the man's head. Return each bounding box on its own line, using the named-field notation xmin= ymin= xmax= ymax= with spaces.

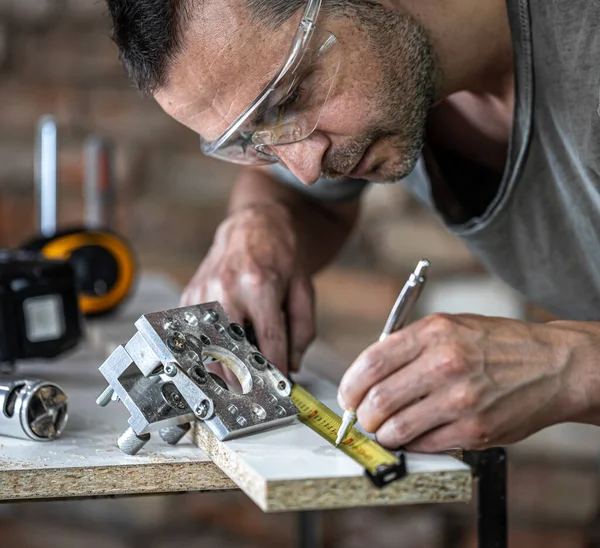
xmin=106 ymin=0 xmax=306 ymax=95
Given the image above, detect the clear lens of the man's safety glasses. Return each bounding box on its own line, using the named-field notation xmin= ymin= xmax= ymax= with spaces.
xmin=201 ymin=33 xmax=341 ymax=165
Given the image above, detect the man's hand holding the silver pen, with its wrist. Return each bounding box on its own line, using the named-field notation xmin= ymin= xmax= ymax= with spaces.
xmin=339 ymin=314 xmax=600 ymax=452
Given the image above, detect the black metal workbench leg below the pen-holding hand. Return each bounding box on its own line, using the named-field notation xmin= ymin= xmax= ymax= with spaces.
xmin=464 ymin=448 xmax=508 ymax=548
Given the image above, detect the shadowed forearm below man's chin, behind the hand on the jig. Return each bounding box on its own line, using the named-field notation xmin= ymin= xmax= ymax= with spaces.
xmin=229 ymin=164 xmax=359 ymax=275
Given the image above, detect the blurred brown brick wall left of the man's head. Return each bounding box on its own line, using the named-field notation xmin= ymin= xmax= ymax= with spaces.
xmin=0 ymin=0 xmax=236 ymax=264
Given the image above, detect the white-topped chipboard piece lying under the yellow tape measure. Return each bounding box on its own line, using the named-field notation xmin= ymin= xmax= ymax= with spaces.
xmin=194 ymin=374 xmax=472 ymax=512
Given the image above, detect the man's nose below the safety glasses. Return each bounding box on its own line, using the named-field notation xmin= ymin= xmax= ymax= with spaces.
xmin=273 ymin=132 xmax=330 ymax=185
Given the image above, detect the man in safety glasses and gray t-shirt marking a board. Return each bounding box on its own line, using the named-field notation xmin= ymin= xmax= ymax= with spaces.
xmin=108 ymin=0 xmax=600 ymax=452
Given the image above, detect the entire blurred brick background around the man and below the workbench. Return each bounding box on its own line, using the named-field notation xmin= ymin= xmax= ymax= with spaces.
xmin=0 ymin=0 xmax=600 ymax=548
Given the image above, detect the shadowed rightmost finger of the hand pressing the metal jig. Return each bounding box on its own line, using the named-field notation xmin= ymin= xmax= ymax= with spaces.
xmin=287 ymin=276 xmax=315 ymax=371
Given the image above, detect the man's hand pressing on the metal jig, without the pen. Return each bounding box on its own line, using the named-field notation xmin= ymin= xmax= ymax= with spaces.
xmin=180 ymin=203 xmax=315 ymax=377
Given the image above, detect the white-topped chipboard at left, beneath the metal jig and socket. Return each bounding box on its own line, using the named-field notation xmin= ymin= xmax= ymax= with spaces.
xmin=0 ymin=347 xmax=236 ymax=500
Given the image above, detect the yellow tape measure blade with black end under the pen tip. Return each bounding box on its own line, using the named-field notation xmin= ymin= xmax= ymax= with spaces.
xmin=291 ymin=383 xmax=407 ymax=487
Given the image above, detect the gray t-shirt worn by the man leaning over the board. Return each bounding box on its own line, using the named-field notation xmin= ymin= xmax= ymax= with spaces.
xmin=274 ymin=0 xmax=600 ymax=320
